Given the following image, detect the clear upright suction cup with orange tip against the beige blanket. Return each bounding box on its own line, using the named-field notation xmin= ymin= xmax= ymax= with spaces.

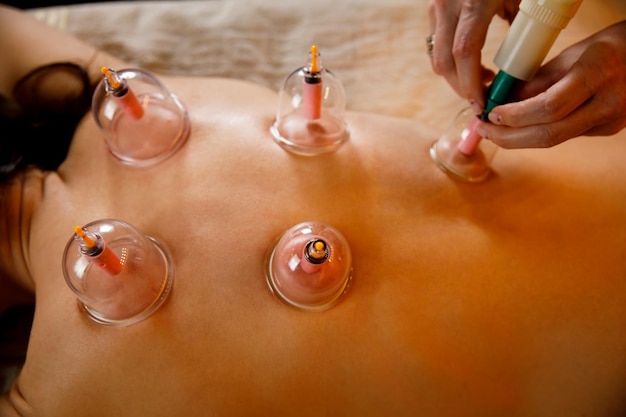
xmin=270 ymin=46 xmax=349 ymax=156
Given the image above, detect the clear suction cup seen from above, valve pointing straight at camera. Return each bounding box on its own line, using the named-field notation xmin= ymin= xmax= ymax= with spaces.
xmin=266 ymin=222 xmax=352 ymax=311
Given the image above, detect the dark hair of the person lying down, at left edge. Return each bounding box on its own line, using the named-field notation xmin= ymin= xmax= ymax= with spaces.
xmin=0 ymin=62 xmax=95 ymax=182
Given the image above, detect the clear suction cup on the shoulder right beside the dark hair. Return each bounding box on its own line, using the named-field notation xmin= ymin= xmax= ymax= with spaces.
xmin=92 ymin=68 xmax=190 ymax=166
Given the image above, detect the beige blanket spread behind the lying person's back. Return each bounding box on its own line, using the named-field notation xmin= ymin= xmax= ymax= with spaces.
xmin=33 ymin=0 xmax=626 ymax=129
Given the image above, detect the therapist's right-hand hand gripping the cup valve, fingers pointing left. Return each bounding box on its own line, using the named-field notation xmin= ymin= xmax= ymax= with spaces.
xmin=477 ymin=21 xmax=626 ymax=148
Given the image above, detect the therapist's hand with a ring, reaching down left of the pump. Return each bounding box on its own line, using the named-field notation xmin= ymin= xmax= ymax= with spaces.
xmin=428 ymin=0 xmax=520 ymax=114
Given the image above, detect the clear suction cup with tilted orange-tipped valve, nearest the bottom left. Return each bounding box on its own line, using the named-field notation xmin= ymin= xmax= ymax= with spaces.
xmin=63 ymin=219 xmax=174 ymax=326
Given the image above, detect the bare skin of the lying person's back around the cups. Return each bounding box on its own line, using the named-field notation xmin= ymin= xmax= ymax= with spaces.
xmin=0 ymin=5 xmax=626 ymax=417
